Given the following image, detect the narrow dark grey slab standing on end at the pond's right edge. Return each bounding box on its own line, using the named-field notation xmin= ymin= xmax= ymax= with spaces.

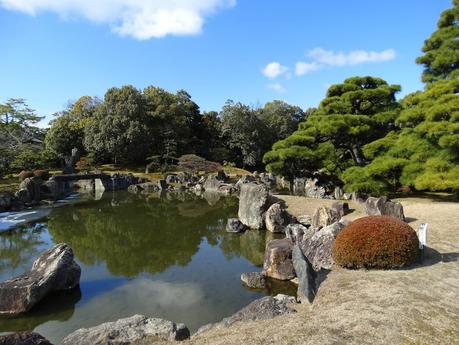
xmin=292 ymin=245 xmax=314 ymax=302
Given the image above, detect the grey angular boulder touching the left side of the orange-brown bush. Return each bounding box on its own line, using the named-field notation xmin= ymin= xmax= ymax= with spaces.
xmin=301 ymin=219 xmax=348 ymax=271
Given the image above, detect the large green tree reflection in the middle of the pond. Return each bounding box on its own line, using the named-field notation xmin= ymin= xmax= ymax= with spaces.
xmin=48 ymin=194 xmax=241 ymax=277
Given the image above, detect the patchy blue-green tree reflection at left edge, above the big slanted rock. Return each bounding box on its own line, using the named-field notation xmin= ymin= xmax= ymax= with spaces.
xmin=0 ymin=226 xmax=46 ymax=274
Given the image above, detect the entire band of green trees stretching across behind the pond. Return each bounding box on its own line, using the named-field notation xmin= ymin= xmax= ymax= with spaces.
xmin=0 ymin=0 xmax=459 ymax=194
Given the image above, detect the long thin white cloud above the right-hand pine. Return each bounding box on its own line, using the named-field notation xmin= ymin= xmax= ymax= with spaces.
xmin=306 ymin=48 xmax=396 ymax=66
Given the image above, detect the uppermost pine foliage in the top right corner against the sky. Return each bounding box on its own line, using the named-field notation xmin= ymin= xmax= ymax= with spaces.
xmin=416 ymin=0 xmax=459 ymax=83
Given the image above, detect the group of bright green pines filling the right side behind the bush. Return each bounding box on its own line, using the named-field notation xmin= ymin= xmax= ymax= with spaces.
xmin=264 ymin=0 xmax=459 ymax=194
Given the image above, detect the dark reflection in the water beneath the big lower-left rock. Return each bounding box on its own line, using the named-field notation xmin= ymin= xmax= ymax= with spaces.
xmin=0 ymin=287 xmax=81 ymax=332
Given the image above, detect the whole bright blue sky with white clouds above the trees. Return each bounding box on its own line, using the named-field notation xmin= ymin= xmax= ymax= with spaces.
xmin=0 ymin=0 xmax=451 ymax=126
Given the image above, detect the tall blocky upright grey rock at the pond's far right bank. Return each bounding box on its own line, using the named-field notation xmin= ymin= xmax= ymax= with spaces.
xmin=238 ymin=183 xmax=270 ymax=230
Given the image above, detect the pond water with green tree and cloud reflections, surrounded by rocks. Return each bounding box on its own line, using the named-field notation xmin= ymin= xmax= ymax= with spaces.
xmin=0 ymin=192 xmax=294 ymax=344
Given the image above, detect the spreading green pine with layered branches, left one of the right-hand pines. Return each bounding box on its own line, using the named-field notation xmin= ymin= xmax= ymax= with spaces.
xmin=263 ymin=77 xmax=400 ymax=183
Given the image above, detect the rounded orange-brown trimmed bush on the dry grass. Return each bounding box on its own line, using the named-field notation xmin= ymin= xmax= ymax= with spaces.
xmin=332 ymin=216 xmax=419 ymax=268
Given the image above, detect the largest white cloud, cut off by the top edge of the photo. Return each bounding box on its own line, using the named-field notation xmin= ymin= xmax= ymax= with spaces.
xmin=0 ymin=0 xmax=236 ymax=40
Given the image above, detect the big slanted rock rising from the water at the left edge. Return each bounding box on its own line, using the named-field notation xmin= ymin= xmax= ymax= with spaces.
xmin=0 ymin=243 xmax=81 ymax=314
